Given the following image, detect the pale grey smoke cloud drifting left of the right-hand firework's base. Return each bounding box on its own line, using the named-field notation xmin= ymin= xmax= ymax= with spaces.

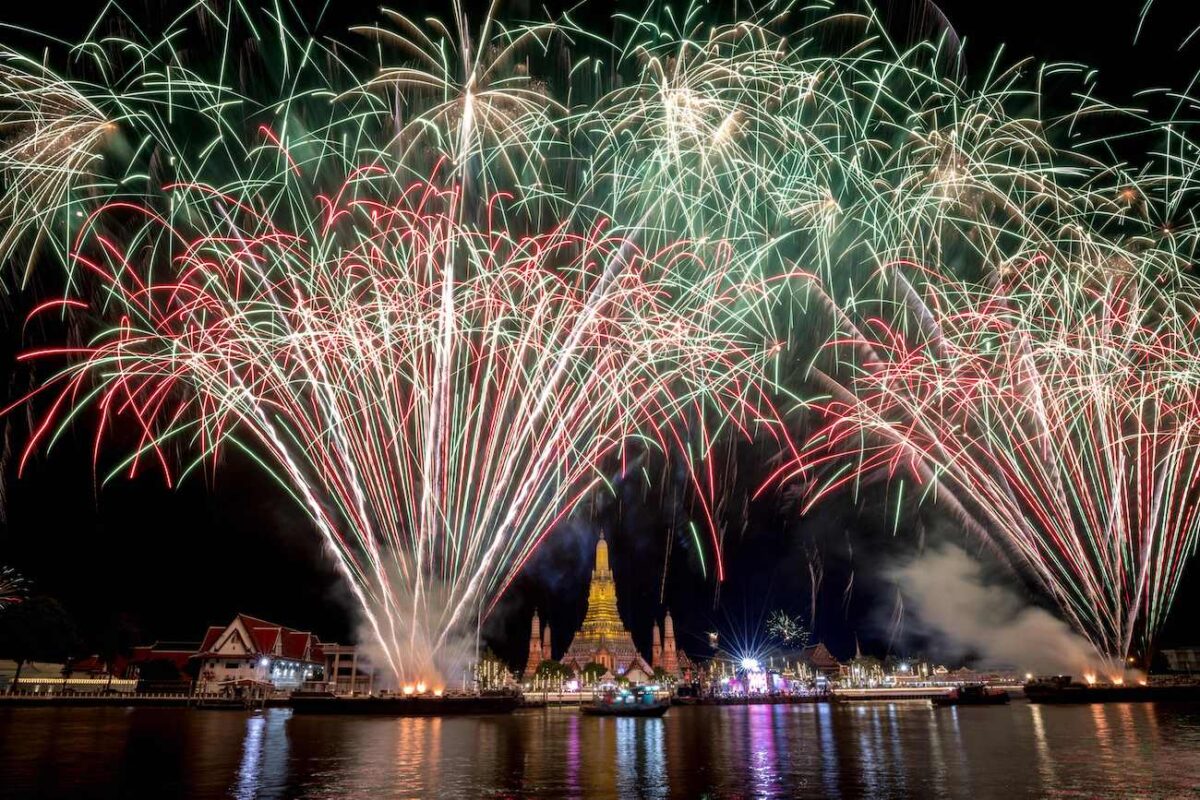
xmin=892 ymin=545 xmax=1109 ymax=679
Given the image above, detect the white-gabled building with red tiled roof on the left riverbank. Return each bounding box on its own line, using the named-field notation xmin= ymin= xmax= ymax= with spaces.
xmin=192 ymin=614 xmax=325 ymax=693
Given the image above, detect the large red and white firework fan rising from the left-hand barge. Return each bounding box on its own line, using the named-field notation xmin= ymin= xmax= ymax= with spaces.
xmin=16 ymin=170 xmax=787 ymax=678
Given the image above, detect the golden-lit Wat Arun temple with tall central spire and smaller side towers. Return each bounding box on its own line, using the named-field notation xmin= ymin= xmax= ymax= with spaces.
xmin=524 ymin=534 xmax=688 ymax=680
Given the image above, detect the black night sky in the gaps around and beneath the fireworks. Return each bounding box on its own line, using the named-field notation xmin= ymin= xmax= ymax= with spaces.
xmin=0 ymin=0 xmax=1200 ymax=671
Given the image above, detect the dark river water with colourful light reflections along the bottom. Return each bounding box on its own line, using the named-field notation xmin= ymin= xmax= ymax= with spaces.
xmin=0 ymin=700 xmax=1200 ymax=800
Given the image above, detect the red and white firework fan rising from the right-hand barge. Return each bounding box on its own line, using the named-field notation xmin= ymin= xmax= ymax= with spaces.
xmin=792 ymin=267 xmax=1200 ymax=663
